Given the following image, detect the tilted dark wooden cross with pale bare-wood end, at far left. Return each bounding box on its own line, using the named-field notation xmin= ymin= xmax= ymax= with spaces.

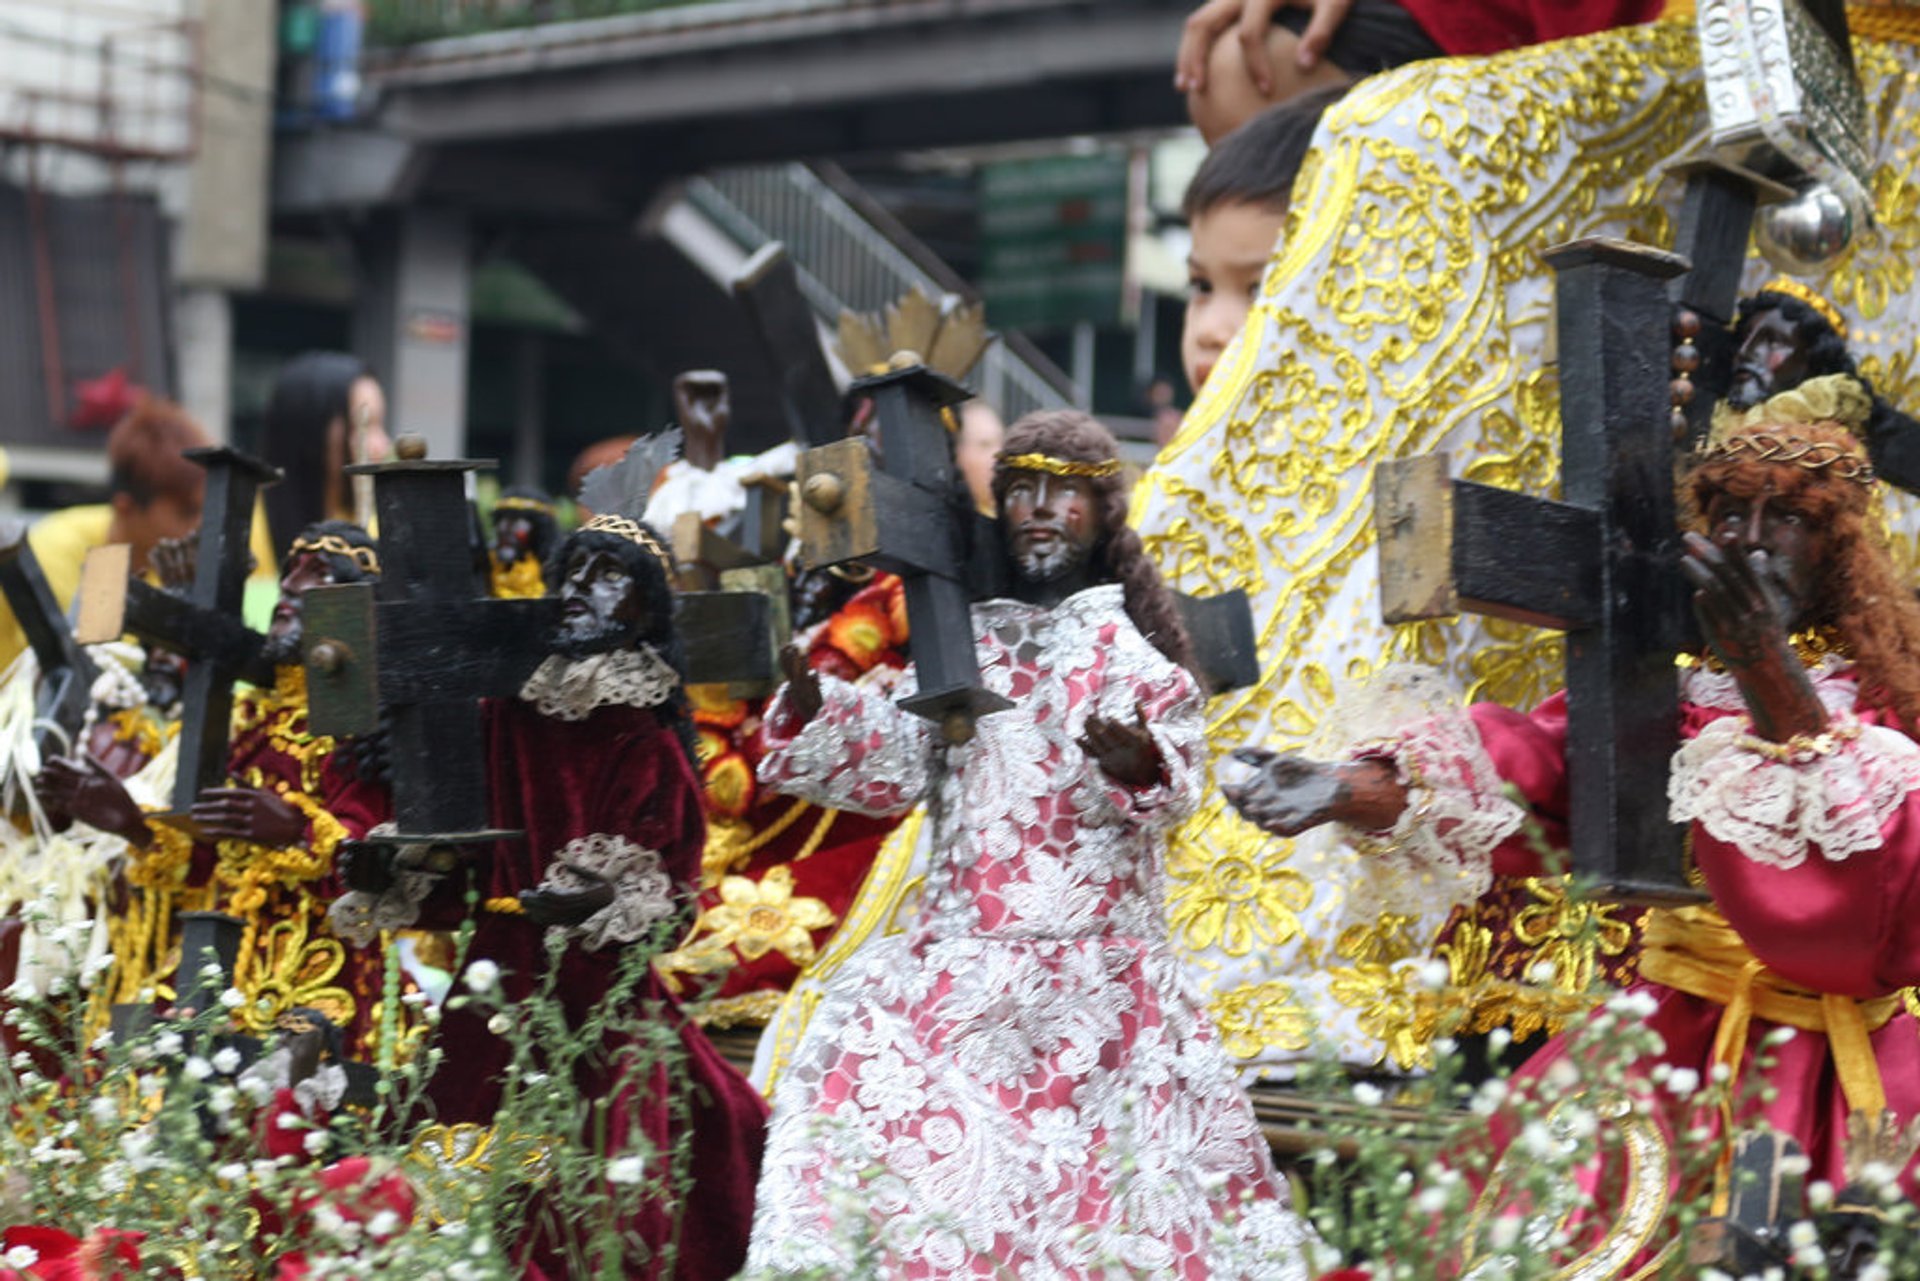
xmin=73 ymin=446 xmax=280 ymax=814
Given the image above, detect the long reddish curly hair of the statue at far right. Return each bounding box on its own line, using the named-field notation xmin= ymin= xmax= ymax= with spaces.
xmin=1688 ymin=423 xmax=1920 ymax=728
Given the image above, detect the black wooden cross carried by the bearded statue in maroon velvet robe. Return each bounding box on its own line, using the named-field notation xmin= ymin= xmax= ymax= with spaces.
xmin=301 ymin=438 xmax=774 ymax=845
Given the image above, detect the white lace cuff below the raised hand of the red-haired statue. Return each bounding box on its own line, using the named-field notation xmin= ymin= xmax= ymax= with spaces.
xmin=1667 ymin=716 xmax=1920 ymax=868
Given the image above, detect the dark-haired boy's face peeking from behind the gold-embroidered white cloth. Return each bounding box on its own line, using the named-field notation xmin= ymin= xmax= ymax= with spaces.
xmin=1181 ymin=85 xmax=1346 ymax=396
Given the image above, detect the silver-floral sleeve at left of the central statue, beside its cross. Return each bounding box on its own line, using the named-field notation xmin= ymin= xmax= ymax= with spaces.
xmin=760 ymin=670 xmax=933 ymax=818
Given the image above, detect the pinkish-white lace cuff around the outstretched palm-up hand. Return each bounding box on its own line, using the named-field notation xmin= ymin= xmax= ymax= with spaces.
xmin=1348 ymin=711 xmax=1526 ymax=914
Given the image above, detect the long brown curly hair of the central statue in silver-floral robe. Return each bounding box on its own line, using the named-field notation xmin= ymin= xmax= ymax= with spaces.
xmin=993 ymin=409 xmax=1190 ymax=666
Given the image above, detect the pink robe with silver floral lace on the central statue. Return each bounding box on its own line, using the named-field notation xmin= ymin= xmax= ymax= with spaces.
xmin=749 ymin=586 xmax=1308 ymax=1281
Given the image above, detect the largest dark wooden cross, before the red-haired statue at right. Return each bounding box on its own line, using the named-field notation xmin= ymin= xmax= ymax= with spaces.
xmin=1375 ymin=238 xmax=1701 ymax=903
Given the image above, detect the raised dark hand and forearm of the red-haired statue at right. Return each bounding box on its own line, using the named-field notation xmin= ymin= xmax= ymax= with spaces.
xmin=1680 ymin=534 xmax=1828 ymax=743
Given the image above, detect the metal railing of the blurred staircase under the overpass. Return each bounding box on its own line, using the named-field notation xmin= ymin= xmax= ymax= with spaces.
xmin=685 ymin=163 xmax=1073 ymax=421
